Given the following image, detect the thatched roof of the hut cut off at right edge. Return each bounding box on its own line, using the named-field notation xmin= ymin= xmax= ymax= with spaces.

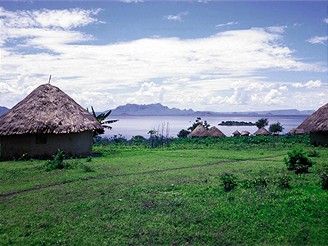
xmin=296 ymin=103 xmax=328 ymax=132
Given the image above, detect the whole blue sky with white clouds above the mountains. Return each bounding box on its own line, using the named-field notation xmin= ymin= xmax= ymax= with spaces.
xmin=0 ymin=0 xmax=328 ymax=112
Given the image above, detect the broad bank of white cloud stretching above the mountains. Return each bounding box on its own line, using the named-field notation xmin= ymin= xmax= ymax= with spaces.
xmin=0 ymin=9 xmax=328 ymax=111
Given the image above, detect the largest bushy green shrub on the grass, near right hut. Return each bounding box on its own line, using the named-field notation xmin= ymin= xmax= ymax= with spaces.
xmin=284 ymin=149 xmax=313 ymax=174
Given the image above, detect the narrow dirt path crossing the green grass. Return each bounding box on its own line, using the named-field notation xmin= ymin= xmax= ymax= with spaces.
xmin=0 ymin=155 xmax=284 ymax=199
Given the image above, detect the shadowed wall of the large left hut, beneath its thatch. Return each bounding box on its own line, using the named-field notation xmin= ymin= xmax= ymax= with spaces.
xmin=0 ymin=131 xmax=92 ymax=158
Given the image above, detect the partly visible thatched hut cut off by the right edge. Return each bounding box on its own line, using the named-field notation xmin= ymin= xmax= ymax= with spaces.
xmin=296 ymin=103 xmax=328 ymax=146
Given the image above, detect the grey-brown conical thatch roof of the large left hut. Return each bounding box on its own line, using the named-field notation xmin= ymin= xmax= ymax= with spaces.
xmin=0 ymin=84 xmax=102 ymax=135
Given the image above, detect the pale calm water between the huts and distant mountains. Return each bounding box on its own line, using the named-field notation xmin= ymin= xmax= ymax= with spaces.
xmin=102 ymin=116 xmax=308 ymax=139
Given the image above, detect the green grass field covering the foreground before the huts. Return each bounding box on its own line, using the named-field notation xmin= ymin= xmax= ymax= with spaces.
xmin=0 ymin=137 xmax=328 ymax=245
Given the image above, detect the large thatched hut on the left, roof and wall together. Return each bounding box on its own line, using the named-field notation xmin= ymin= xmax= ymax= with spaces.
xmin=0 ymin=84 xmax=102 ymax=158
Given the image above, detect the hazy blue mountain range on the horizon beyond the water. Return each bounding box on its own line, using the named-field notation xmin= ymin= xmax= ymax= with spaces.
xmin=0 ymin=103 xmax=314 ymax=117
